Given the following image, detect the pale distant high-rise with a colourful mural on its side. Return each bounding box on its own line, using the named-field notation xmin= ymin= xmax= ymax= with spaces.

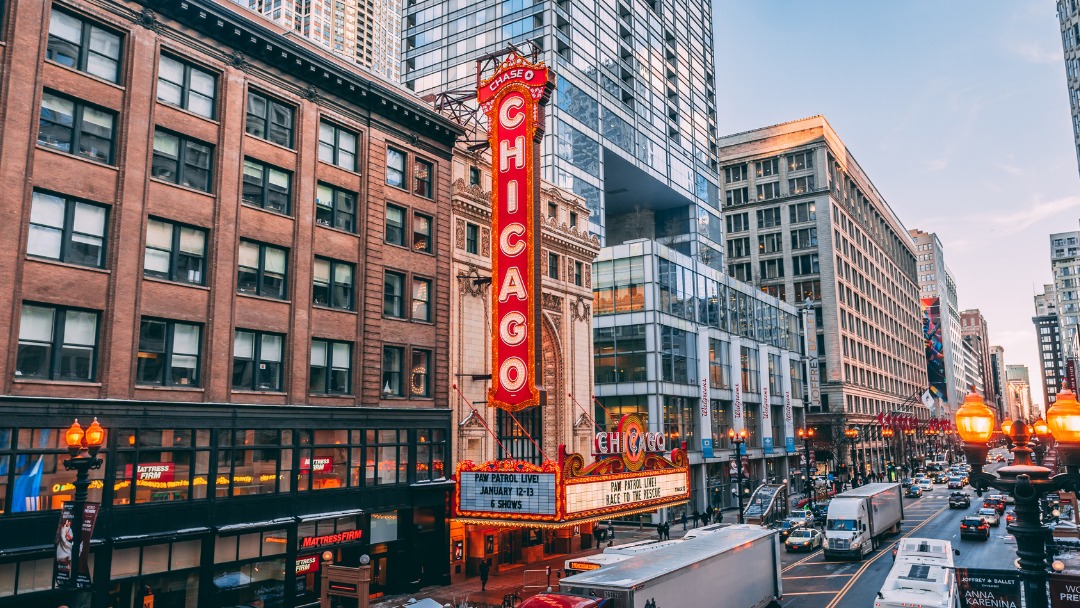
xmin=908 ymin=229 xmax=968 ymax=419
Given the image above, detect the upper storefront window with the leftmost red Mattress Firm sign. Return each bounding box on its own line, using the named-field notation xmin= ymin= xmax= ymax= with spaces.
xmin=112 ymin=429 xmax=211 ymax=504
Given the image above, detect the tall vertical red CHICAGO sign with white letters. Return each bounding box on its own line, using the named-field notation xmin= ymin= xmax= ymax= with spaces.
xmin=476 ymin=53 xmax=554 ymax=411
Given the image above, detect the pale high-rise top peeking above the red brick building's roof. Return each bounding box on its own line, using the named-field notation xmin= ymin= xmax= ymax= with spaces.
xmin=227 ymin=0 xmax=401 ymax=83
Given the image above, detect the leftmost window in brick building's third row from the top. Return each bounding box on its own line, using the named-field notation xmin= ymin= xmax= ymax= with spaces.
xmin=26 ymin=190 xmax=108 ymax=268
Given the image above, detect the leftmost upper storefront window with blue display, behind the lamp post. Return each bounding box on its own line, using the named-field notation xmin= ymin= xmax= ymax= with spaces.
xmin=11 ymin=429 xmax=108 ymax=513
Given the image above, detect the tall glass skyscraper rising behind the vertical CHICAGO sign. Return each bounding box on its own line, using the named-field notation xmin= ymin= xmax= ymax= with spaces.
xmin=402 ymin=0 xmax=723 ymax=254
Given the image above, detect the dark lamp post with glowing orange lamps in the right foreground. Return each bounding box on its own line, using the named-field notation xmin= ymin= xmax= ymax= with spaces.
xmin=956 ymin=384 xmax=1080 ymax=608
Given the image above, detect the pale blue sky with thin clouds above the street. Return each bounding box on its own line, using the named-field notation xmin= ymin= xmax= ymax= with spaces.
xmin=713 ymin=0 xmax=1080 ymax=403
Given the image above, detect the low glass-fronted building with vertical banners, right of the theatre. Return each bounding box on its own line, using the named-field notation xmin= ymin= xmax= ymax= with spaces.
xmin=593 ymin=239 xmax=806 ymax=515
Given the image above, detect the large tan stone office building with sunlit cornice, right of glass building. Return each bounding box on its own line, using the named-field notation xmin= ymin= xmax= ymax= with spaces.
xmin=720 ymin=116 xmax=930 ymax=483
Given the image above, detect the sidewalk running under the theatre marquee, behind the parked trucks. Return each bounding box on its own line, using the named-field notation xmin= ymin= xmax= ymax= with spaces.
xmin=372 ymin=520 xmax=717 ymax=608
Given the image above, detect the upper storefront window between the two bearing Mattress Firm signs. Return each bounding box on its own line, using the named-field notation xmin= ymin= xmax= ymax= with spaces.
xmin=216 ymin=430 xmax=293 ymax=497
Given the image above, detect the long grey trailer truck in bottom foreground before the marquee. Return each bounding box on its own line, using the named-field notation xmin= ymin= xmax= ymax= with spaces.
xmin=519 ymin=525 xmax=783 ymax=608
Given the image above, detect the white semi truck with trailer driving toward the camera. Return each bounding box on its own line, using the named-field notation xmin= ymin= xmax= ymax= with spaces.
xmin=823 ymin=484 xmax=904 ymax=559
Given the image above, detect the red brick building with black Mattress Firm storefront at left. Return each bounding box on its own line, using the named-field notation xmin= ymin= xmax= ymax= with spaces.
xmin=0 ymin=0 xmax=460 ymax=606
